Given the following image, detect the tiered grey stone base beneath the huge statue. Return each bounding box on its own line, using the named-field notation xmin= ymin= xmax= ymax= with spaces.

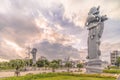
xmin=86 ymin=59 xmax=104 ymax=73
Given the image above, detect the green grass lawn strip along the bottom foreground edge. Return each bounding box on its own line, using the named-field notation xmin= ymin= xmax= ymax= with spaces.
xmin=0 ymin=73 xmax=116 ymax=80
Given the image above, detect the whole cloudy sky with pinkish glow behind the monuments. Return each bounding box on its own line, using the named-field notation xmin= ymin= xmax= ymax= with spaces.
xmin=0 ymin=0 xmax=120 ymax=60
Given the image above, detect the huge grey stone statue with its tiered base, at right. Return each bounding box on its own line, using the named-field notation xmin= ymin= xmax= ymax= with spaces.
xmin=85 ymin=6 xmax=107 ymax=73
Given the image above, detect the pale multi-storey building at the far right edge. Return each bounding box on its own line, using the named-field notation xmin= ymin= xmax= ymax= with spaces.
xmin=110 ymin=50 xmax=120 ymax=65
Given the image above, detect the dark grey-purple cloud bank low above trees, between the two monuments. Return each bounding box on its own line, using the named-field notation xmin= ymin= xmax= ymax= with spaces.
xmin=34 ymin=41 xmax=80 ymax=60
